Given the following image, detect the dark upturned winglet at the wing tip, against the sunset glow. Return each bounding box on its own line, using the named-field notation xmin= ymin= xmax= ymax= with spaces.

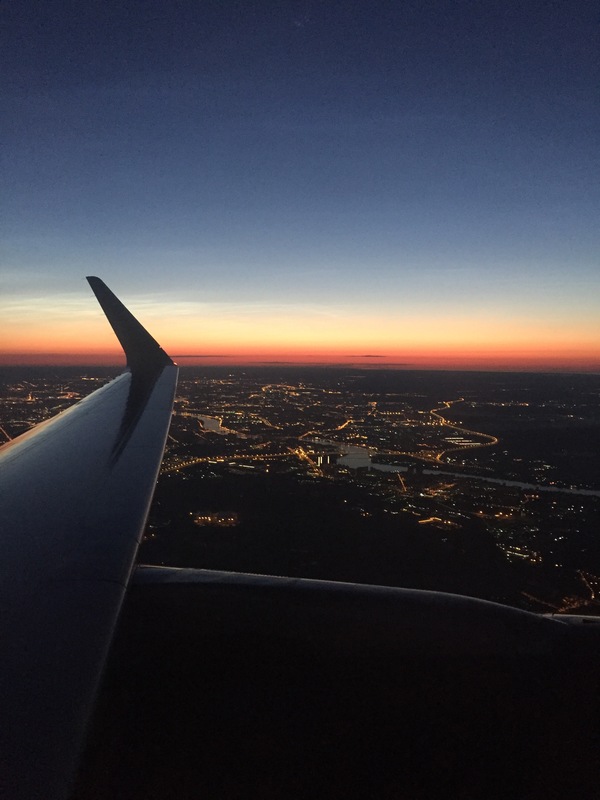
xmin=87 ymin=276 xmax=174 ymax=374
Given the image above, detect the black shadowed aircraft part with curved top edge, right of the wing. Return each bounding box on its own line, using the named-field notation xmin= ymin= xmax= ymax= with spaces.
xmin=76 ymin=567 xmax=600 ymax=800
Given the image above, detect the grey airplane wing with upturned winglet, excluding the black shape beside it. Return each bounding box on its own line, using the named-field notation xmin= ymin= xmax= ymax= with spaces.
xmin=0 ymin=277 xmax=177 ymax=800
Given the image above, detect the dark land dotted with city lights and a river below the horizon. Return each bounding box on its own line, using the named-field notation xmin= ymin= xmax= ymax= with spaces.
xmin=0 ymin=367 xmax=600 ymax=614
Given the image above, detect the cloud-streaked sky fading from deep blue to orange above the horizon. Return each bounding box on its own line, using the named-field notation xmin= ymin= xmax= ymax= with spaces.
xmin=0 ymin=0 xmax=600 ymax=371
